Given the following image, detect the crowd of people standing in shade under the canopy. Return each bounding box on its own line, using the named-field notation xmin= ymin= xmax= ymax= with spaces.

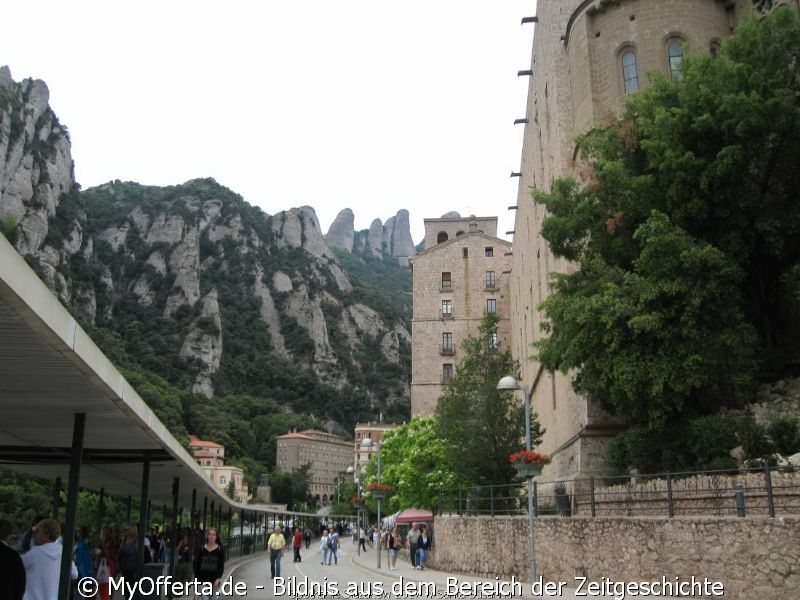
xmin=0 ymin=517 xmax=225 ymax=600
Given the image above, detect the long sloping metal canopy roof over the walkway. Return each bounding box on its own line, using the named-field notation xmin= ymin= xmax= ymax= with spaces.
xmin=0 ymin=236 xmax=244 ymax=510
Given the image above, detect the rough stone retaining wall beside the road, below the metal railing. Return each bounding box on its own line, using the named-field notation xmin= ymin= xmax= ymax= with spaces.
xmin=431 ymin=517 xmax=800 ymax=600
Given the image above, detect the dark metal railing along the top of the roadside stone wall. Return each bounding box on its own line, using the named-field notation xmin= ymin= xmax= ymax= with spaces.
xmin=438 ymin=466 xmax=800 ymax=517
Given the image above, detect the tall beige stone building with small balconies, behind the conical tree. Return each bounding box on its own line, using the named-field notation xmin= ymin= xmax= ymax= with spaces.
xmin=409 ymin=216 xmax=511 ymax=416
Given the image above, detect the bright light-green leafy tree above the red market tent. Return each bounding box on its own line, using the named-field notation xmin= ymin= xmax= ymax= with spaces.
xmin=365 ymin=417 xmax=459 ymax=512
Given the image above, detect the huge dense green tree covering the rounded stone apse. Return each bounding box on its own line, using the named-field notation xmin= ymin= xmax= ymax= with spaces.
xmin=535 ymin=9 xmax=800 ymax=426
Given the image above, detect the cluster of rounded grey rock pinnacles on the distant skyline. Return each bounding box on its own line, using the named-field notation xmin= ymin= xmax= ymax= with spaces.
xmin=325 ymin=208 xmax=416 ymax=266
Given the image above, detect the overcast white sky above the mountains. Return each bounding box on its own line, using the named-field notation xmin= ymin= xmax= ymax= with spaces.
xmin=0 ymin=0 xmax=536 ymax=242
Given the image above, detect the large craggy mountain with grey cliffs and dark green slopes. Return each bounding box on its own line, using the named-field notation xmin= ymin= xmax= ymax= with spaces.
xmin=0 ymin=68 xmax=413 ymax=452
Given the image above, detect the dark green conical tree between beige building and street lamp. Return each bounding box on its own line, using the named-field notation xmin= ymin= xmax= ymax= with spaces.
xmin=436 ymin=313 xmax=542 ymax=485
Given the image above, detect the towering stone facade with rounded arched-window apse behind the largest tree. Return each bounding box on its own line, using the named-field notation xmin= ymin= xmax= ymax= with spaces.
xmin=510 ymin=0 xmax=798 ymax=479
